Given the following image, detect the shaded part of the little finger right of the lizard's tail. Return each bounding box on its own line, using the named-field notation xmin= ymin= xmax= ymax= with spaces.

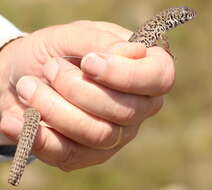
xmin=33 ymin=127 xmax=120 ymax=171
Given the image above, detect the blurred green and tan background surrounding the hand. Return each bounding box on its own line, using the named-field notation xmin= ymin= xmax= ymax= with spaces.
xmin=0 ymin=0 xmax=212 ymax=190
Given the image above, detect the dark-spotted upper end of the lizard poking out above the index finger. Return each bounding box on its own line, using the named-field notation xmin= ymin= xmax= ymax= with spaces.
xmin=129 ymin=7 xmax=196 ymax=55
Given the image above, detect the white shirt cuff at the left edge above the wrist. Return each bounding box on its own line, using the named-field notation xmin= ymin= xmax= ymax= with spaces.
xmin=0 ymin=15 xmax=25 ymax=48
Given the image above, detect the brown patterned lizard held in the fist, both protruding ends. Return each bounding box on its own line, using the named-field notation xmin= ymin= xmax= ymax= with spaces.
xmin=8 ymin=7 xmax=196 ymax=186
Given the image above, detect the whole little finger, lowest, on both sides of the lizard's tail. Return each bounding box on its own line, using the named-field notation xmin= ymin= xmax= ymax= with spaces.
xmin=0 ymin=113 xmax=136 ymax=171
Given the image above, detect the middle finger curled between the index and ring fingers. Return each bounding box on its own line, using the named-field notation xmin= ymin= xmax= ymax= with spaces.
xmin=44 ymin=58 xmax=162 ymax=126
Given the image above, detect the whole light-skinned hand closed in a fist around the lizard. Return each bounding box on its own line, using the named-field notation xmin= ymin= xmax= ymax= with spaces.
xmin=0 ymin=21 xmax=175 ymax=171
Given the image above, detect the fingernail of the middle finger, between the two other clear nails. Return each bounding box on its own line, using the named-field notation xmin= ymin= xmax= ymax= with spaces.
xmin=43 ymin=59 xmax=59 ymax=82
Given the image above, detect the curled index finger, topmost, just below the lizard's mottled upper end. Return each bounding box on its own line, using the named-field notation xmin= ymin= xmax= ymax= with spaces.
xmin=81 ymin=47 xmax=175 ymax=96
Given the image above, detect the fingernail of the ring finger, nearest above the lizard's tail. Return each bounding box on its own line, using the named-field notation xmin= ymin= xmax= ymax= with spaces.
xmin=16 ymin=76 xmax=37 ymax=101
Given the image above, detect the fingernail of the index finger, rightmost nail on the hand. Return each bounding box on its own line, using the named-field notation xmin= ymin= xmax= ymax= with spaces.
xmin=81 ymin=53 xmax=107 ymax=77
